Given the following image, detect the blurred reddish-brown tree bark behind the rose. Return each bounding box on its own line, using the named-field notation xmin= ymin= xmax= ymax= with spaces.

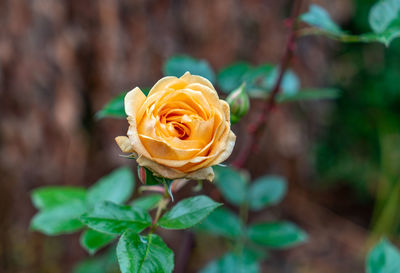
xmin=0 ymin=0 xmax=363 ymax=273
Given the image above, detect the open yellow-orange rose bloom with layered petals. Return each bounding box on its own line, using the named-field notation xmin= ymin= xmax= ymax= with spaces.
xmin=115 ymin=72 xmax=236 ymax=181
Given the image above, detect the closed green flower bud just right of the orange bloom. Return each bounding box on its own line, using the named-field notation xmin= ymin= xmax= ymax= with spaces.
xmin=226 ymin=83 xmax=250 ymax=124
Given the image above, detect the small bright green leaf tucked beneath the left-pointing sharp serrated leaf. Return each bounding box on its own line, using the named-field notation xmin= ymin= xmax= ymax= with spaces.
xmin=80 ymin=229 xmax=116 ymax=254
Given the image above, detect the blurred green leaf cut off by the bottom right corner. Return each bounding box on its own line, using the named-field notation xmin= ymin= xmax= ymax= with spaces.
xmin=366 ymin=236 xmax=400 ymax=273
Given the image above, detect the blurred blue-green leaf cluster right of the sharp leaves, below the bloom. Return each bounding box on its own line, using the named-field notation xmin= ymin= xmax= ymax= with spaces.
xmin=195 ymin=166 xmax=307 ymax=273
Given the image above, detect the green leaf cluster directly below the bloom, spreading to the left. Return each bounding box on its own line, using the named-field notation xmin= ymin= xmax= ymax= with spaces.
xmin=31 ymin=167 xmax=221 ymax=273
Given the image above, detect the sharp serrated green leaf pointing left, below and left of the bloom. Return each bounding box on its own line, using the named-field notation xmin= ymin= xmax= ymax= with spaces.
xmin=81 ymin=201 xmax=151 ymax=234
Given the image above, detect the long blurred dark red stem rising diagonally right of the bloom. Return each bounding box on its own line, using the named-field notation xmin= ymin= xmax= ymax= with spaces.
xmin=233 ymin=0 xmax=302 ymax=168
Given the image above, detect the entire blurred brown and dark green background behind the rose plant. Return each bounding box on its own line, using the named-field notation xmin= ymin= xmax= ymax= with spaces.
xmin=0 ymin=0 xmax=400 ymax=273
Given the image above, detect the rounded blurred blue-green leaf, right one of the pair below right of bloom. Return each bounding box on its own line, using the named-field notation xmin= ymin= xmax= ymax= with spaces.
xmin=248 ymin=175 xmax=287 ymax=210
